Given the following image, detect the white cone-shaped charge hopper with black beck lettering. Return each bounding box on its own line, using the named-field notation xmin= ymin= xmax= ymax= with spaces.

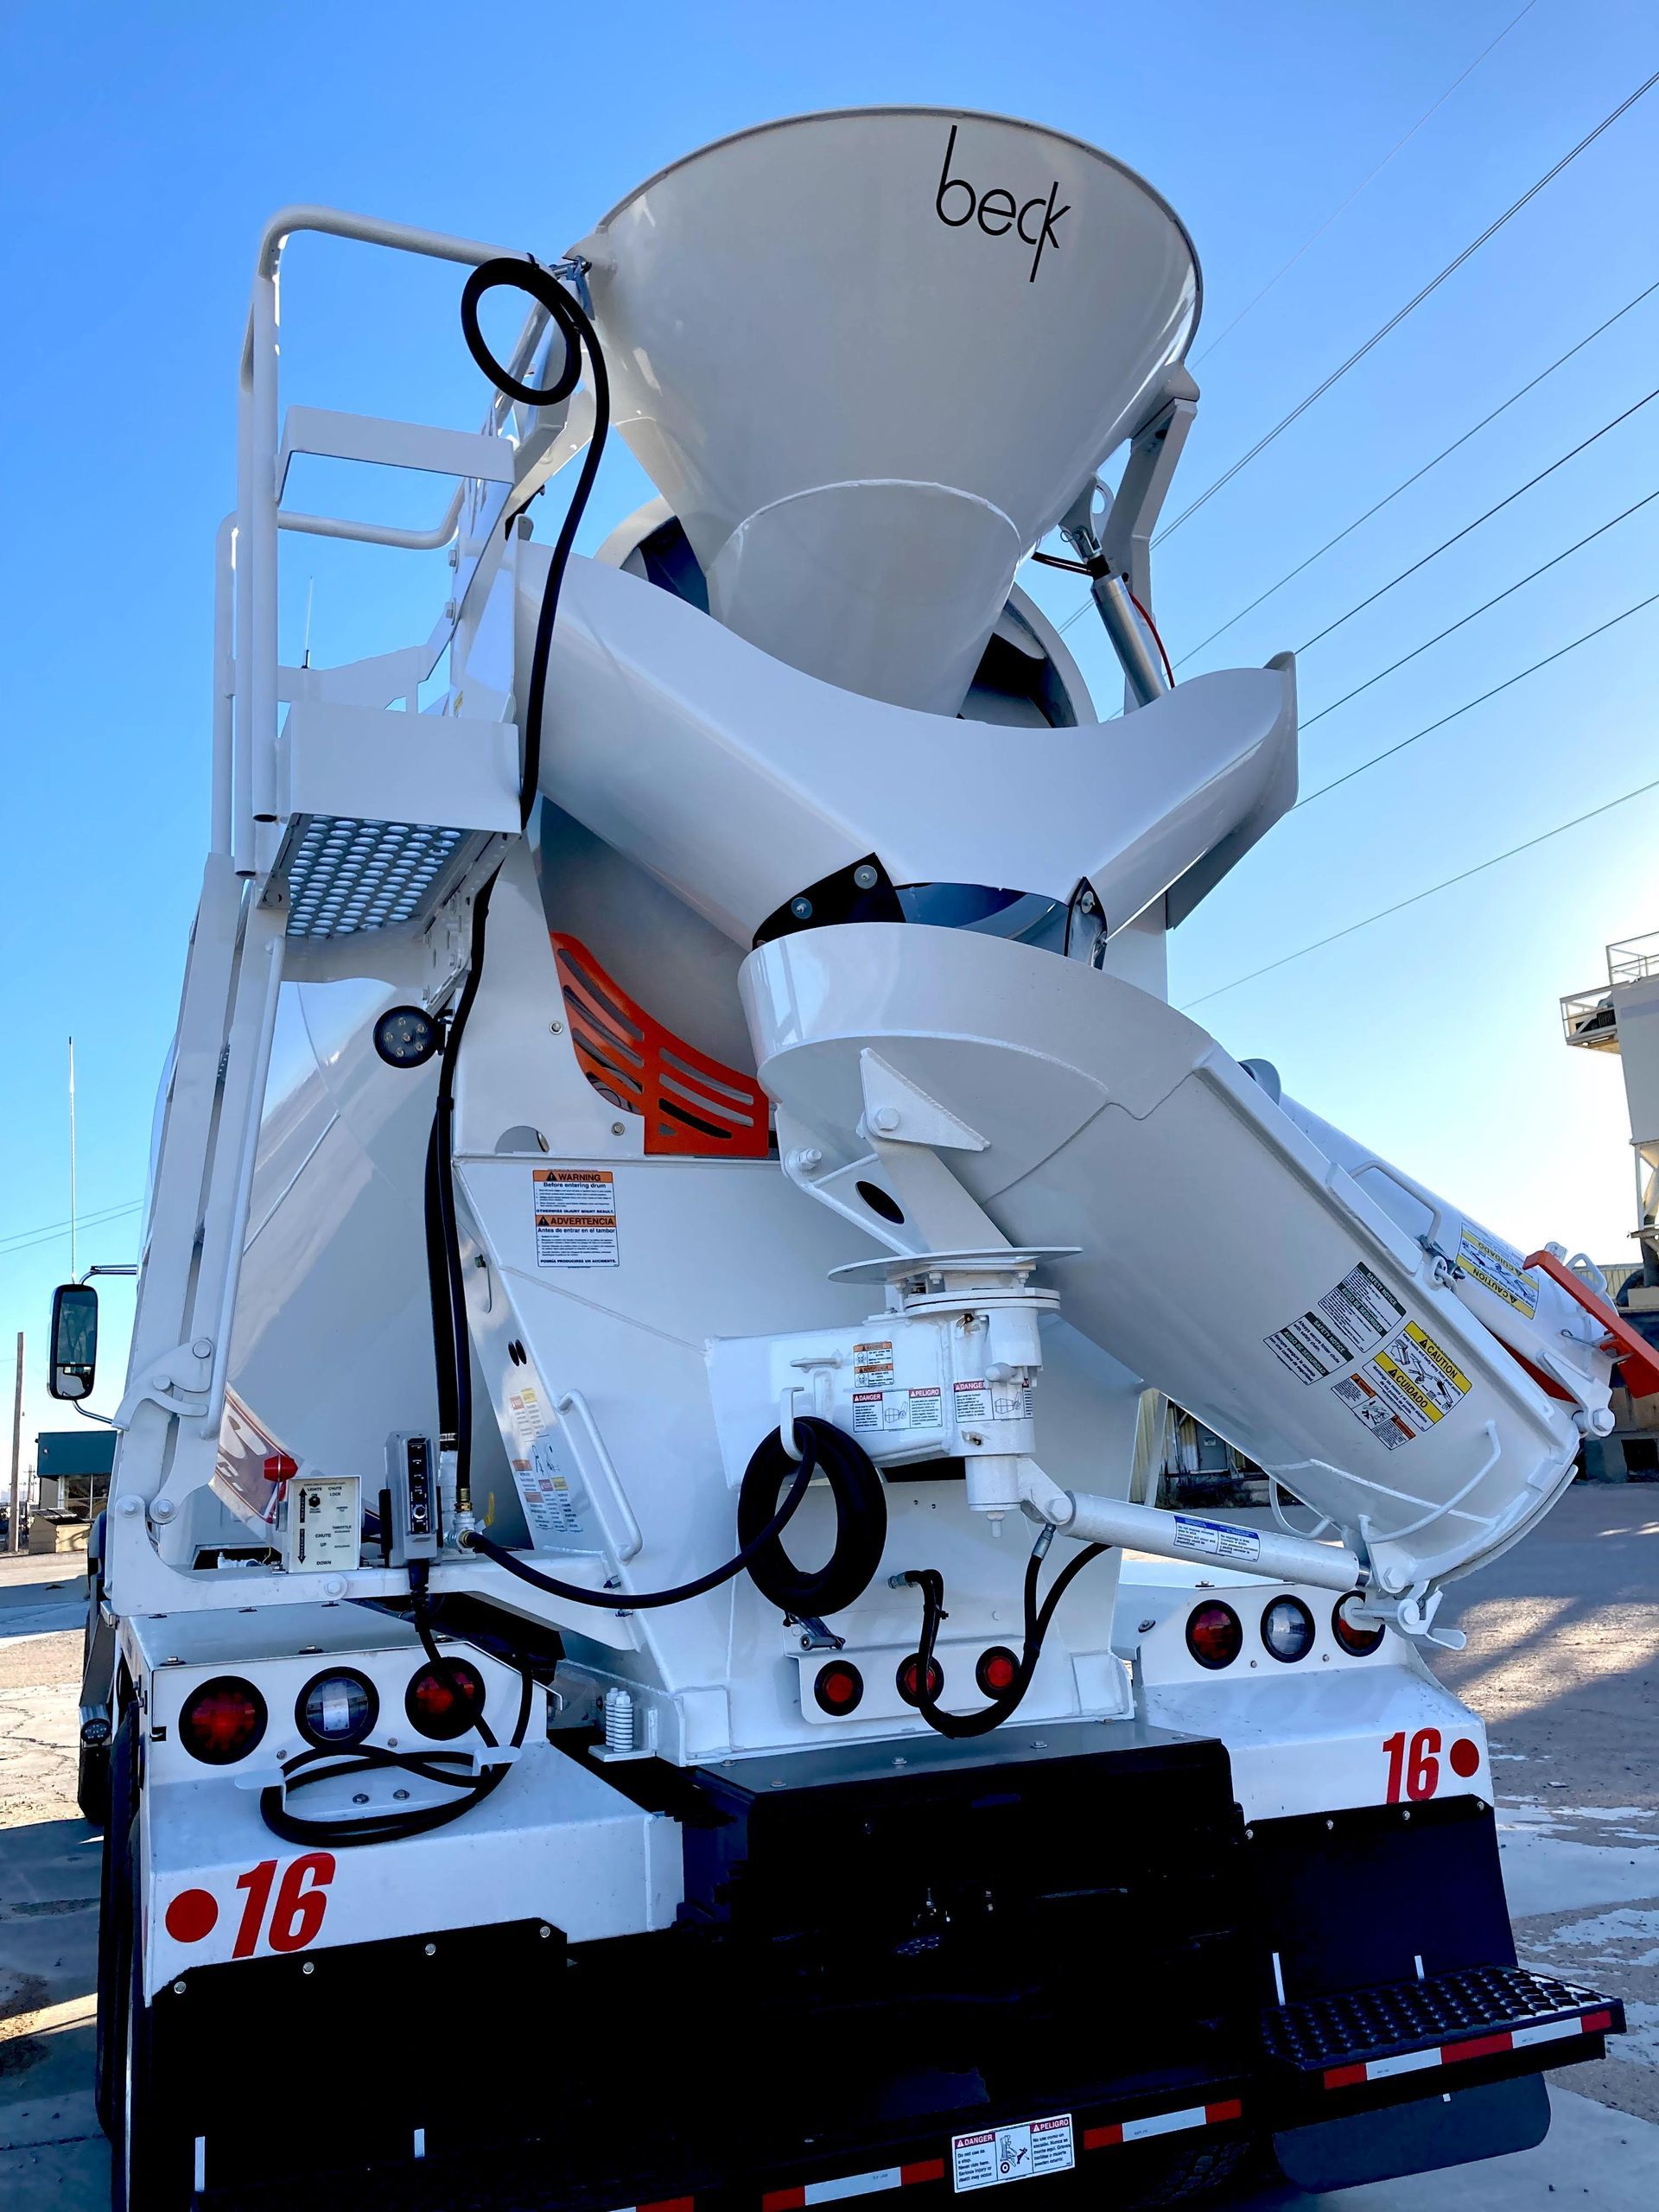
xmin=575 ymin=108 xmax=1199 ymax=715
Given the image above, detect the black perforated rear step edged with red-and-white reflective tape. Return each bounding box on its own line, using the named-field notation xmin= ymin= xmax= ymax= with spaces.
xmin=1261 ymin=1967 xmax=1624 ymax=2090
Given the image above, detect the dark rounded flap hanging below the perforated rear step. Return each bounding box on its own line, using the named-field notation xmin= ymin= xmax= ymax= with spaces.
xmin=1274 ymin=2075 xmax=1551 ymax=2196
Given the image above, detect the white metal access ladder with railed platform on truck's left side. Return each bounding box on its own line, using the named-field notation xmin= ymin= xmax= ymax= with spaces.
xmin=104 ymin=206 xmax=593 ymax=1612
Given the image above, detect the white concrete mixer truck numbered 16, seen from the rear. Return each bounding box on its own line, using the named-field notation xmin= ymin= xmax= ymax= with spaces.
xmin=53 ymin=108 xmax=1659 ymax=2212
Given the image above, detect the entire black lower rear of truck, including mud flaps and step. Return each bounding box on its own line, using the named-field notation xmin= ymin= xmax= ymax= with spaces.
xmin=153 ymin=1726 xmax=1624 ymax=2212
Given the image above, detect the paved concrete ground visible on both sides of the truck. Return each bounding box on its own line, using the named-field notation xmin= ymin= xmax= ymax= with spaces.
xmin=0 ymin=1484 xmax=1659 ymax=2212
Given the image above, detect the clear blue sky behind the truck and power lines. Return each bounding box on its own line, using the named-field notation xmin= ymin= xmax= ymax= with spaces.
xmin=0 ymin=0 xmax=1659 ymax=1435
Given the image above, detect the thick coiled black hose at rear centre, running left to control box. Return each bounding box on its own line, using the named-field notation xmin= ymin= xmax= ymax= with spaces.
xmin=460 ymin=1418 xmax=887 ymax=1619
